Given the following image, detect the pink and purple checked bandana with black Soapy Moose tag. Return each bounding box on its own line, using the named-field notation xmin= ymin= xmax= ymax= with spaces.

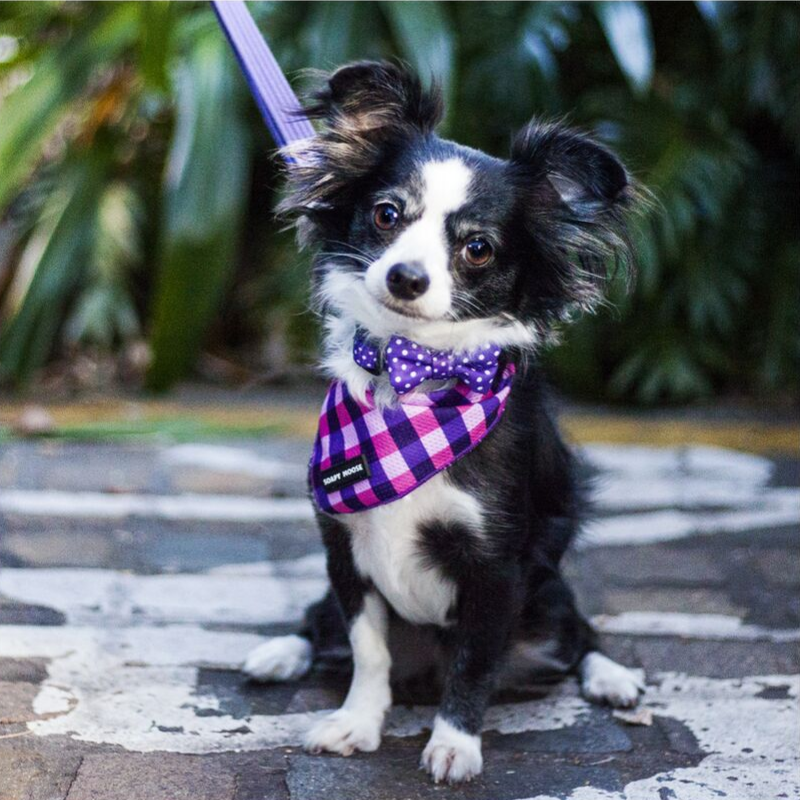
xmin=309 ymin=364 xmax=514 ymax=514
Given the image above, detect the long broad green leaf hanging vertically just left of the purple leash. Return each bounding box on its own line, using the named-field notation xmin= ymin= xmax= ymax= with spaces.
xmin=147 ymin=29 xmax=249 ymax=391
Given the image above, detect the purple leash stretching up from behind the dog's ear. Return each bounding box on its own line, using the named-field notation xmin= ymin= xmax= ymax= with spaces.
xmin=211 ymin=0 xmax=314 ymax=153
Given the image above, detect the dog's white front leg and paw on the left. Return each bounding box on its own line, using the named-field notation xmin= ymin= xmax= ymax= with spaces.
xmin=305 ymin=593 xmax=392 ymax=756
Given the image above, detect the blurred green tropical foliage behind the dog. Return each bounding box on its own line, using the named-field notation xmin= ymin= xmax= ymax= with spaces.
xmin=0 ymin=2 xmax=800 ymax=404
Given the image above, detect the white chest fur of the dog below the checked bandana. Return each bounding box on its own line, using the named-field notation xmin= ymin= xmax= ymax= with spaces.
xmin=342 ymin=473 xmax=482 ymax=625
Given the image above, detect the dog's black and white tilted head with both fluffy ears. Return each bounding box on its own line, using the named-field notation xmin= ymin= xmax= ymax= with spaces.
xmin=282 ymin=62 xmax=634 ymax=349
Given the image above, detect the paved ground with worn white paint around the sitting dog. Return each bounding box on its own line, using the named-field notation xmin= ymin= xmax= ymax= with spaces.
xmin=0 ymin=412 xmax=800 ymax=800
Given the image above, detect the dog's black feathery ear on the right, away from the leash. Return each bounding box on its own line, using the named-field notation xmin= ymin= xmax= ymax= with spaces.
xmin=510 ymin=122 xmax=640 ymax=307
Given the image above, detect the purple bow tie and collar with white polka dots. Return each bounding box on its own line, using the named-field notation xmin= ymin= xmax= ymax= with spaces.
xmin=353 ymin=330 xmax=501 ymax=394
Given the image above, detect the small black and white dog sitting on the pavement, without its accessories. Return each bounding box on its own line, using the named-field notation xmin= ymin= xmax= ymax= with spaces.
xmin=244 ymin=62 xmax=643 ymax=782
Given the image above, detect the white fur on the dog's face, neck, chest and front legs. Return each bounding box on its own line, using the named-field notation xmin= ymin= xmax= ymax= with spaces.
xmin=306 ymin=159 xmax=536 ymax=768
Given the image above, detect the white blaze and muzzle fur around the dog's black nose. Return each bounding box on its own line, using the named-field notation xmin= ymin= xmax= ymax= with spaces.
xmin=365 ymin=158 xmax=472 ymax=319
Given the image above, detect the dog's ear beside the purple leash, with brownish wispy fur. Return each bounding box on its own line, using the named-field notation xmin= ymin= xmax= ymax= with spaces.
xmin=278 ymin=61 xmax=442 ymax=230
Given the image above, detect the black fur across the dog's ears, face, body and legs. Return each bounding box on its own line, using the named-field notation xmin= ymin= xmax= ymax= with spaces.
xmin=268 ymin=62 xmax=637 ymax=776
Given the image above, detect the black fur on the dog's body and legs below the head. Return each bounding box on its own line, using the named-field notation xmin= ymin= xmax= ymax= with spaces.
xmin=306 ymin=368 xmax=598 ymax=733
